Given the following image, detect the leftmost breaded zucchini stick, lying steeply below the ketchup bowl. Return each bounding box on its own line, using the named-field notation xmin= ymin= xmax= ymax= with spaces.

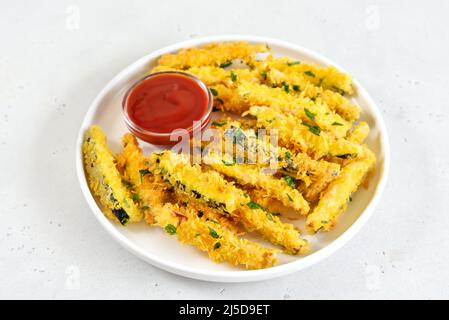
xmin=83 ymin=126 xmax=142 ymax=225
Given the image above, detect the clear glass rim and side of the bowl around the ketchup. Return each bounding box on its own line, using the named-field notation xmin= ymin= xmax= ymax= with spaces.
xmin=122 ymin=71 xmax=214 ymax=145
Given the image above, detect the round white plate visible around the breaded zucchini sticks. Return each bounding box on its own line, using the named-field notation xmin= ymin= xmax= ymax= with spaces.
xmin=76 ymin=36 xmax=390 ymax=282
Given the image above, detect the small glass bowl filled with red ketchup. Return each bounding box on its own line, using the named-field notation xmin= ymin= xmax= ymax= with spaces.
xmin=123 ymin=72 xmax=213 ymax=145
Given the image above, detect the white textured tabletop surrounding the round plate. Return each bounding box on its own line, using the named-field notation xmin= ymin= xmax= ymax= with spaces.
xmin=0 ymin=0 xmax=449 ymax=299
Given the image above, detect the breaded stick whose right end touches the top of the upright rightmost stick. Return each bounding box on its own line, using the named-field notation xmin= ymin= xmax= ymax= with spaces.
xmin=245 ymin=106 xmax=362 ymax=159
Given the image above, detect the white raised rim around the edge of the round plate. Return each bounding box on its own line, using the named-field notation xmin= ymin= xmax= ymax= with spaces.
xmin=75 ymin=34 xmax=390 ymax=282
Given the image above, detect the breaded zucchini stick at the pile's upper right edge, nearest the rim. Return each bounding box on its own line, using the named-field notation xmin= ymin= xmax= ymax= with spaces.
xmin=258 ymin=57 xmax=354 ymax=94
